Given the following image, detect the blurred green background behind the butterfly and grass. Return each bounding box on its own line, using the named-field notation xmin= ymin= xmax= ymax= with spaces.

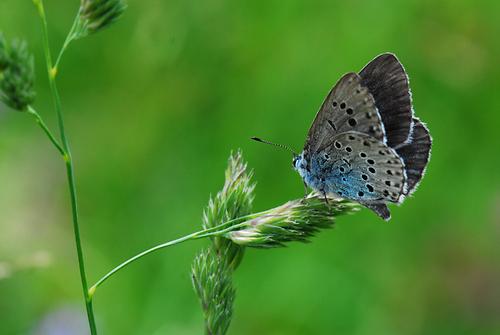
xmin=0 ymin=0 xmax=500 ymax=335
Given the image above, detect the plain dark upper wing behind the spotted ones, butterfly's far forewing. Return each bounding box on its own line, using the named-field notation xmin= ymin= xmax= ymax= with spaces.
xmin=359 ymin=53 xmax=413 ymax=147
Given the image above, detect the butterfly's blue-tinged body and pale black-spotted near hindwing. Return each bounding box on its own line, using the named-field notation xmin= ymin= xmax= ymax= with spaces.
xmin=295 ymin=132 xmax=405 ymax=202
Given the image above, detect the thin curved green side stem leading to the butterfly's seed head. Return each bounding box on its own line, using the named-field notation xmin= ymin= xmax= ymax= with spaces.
xmin=89 ymin=215 xmax=267 ymax=299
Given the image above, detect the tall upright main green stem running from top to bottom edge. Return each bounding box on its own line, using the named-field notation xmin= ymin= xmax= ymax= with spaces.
xmin=33 ymin=0 xmax=97 ymax=335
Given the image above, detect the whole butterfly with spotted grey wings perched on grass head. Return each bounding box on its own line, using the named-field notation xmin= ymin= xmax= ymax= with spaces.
xmin=253 ymin=53 xmax=432 ymax=220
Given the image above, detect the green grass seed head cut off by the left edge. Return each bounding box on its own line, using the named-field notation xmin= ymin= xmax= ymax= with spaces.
xmin=0 ymin=33 xmax=36 ymax=111
